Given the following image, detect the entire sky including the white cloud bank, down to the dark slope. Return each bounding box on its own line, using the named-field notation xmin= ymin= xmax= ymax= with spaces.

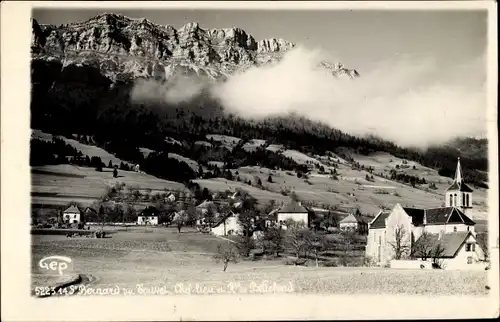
xmin=33 ymin=9 xmax=487 ymax=147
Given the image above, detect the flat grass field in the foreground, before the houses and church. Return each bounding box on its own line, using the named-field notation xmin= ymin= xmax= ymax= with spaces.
xmin=32 ymin=228 xmax=487 ymax=295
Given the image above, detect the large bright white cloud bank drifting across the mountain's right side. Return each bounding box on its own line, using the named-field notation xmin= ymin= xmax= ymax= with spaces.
xmin=212 ymin=48 xmax=486 ymax=147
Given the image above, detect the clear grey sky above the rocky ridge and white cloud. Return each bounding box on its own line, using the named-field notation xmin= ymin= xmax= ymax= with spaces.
xmin=33 ymin=9 xmax=487 ymax=73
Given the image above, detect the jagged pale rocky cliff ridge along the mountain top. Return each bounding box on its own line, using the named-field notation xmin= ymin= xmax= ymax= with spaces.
xmin=31 ymin=13 xmax=359 ymax=82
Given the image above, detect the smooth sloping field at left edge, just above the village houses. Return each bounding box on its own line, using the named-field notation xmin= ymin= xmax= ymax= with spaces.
xmin=31 ymin=164 xmax=186 ymax=206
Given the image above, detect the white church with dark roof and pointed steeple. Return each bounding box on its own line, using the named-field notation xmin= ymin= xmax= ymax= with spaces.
xmin=366 ymin=158 xmax=484 ymax=268
